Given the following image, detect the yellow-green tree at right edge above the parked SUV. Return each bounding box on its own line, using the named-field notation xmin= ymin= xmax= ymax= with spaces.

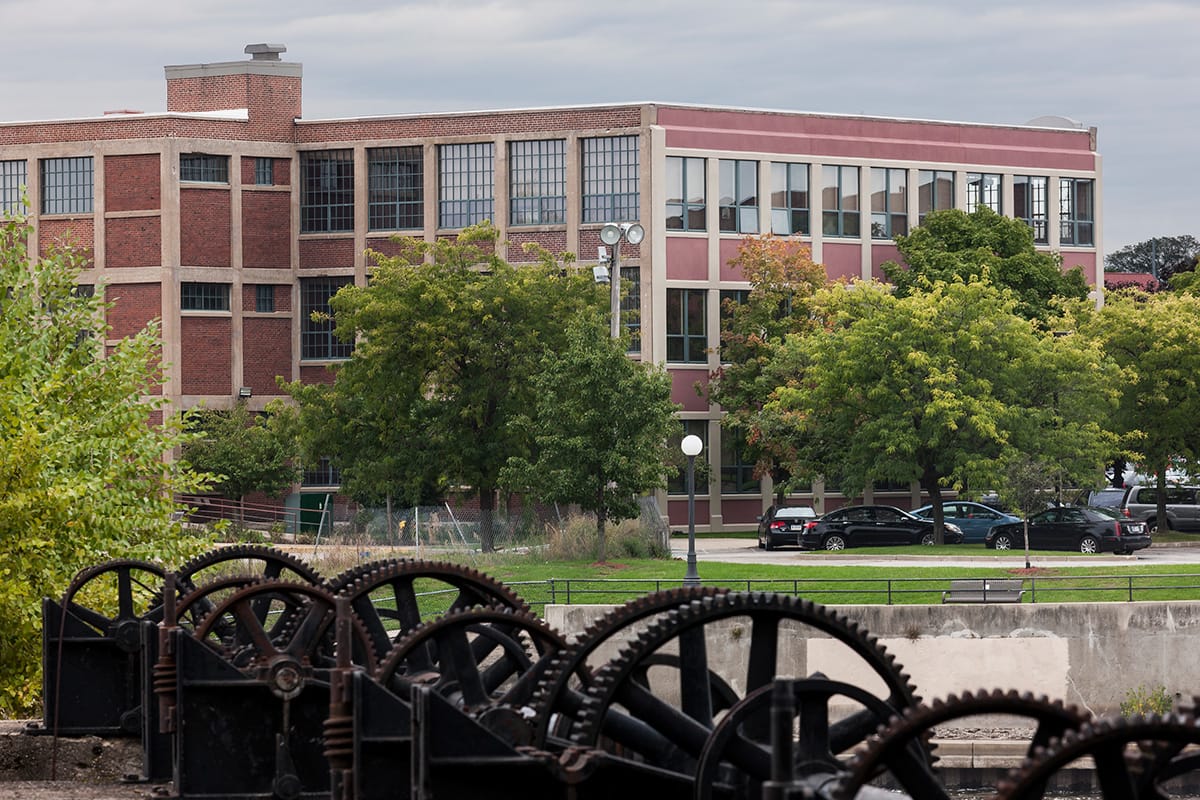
xmin=1074 ymin=290 xmax=1200 ymax=525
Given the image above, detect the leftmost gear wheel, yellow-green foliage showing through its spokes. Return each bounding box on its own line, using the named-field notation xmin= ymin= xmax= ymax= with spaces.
xmin=62 ymin=559 xmax=167 ymax=652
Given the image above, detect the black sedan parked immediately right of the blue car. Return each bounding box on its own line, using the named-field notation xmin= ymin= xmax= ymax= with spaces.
xmin=984 ymin=506 xmax=1150 ymax=555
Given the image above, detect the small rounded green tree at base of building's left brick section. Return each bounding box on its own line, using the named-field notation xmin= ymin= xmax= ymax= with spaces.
xmin=181 ymin=401 xmax=300 ymax=520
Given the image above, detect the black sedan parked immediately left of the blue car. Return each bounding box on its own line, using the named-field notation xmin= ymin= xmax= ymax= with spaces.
xmin=800 ymin=506 xmax=962 ymax=551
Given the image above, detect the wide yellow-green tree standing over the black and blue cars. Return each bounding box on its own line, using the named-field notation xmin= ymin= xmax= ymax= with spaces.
xmin=768 ymin=277 xmax=1117 ymax=541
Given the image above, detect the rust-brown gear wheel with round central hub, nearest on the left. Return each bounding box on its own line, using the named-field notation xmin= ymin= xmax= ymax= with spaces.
xmin=192 ymin=579 xmax=377 ymax=671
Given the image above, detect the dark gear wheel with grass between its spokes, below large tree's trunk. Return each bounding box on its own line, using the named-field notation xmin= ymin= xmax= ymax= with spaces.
xmin=337 ymin=560 xmax=529 ymax=661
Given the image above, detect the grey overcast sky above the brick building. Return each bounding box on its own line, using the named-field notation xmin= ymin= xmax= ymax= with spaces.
xmin=0 ymin=0 xmax=1200 ymax=252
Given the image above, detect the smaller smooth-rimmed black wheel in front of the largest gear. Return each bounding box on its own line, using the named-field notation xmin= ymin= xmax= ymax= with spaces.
xmin=692 ymin=678 xmax=907 ymax=800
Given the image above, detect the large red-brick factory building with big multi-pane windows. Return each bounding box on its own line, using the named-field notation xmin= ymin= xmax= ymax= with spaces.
xmin=0 ymin=44 xmax=1103 ymax=530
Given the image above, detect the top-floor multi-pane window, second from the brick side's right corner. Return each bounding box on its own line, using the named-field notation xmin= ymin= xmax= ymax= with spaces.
xmin=509 ymin=139 xmax=566 ymax=225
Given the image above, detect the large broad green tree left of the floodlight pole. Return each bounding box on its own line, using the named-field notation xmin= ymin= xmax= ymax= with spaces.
xmin=292 ymin=223 xmax=604 ymax=551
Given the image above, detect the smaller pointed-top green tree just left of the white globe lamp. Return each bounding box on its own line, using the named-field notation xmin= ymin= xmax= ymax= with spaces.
xmin=502 ymin=314 xmax=679 ymax=561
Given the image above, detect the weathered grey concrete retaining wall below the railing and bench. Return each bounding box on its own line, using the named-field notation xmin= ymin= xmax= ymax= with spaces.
xmin=544 ymin=602 xmax=1200 ymax=714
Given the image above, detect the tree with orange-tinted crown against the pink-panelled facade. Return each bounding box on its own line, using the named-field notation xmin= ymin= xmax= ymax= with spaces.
xmin=708 ymin=235 xmax=827 ymax=503
